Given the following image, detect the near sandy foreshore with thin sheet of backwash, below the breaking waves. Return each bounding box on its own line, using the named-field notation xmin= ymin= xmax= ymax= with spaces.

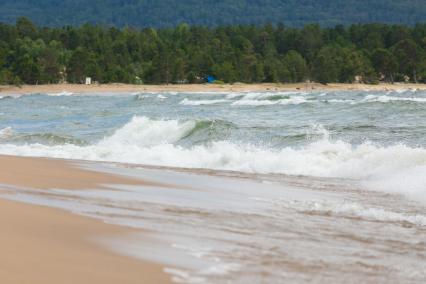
xmin=0 ymin=156 xmax=426 ymax=284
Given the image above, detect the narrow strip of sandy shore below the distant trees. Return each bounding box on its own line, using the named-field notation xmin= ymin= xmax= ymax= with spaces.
xmin=0 ymin=83 xmax=426 ymax=95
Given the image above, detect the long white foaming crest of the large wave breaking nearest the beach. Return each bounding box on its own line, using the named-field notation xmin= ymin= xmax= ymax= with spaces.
xmin=0 ymin=116 xmax=426 ymax=201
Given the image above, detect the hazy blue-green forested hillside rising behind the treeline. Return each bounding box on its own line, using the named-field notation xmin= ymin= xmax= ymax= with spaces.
xmin=0 ymin=0 xmax=426 ymax=27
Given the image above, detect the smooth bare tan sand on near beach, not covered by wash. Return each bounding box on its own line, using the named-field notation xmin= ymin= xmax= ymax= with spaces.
xmin=0 ymin=156 xmax=171 ymax=284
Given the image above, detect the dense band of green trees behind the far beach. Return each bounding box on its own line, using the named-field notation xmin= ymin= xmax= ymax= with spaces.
xmin=0 ymin=18 xmax=426 ymax=84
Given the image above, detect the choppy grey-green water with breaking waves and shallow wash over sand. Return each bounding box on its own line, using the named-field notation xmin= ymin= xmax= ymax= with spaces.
xmin=0 ymin=90 xmax=426 ymax=283
